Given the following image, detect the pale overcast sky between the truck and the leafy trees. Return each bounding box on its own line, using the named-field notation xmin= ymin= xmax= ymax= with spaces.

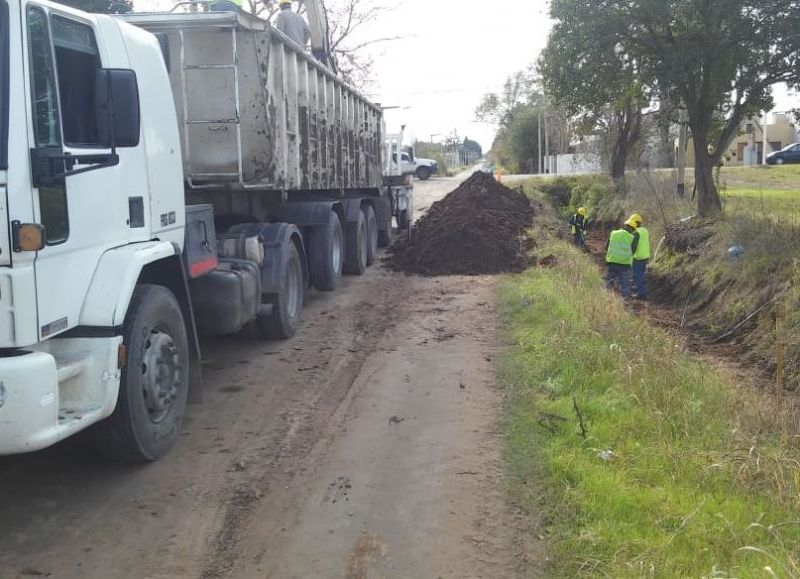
xmin=356 ymin=0 xmax=549 ymax=149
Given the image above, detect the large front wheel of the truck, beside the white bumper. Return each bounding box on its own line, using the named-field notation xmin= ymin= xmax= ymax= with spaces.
xmin=93 ymin=284 xmax=189 ymax=462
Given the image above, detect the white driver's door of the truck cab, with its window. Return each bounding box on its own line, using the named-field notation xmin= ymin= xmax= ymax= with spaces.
xmin=23 ymin=3 xmax=128 ymax=339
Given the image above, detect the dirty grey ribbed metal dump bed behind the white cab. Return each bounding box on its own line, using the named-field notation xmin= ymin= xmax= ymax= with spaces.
xmin=121 ymin=12 xmax=382 ymax=192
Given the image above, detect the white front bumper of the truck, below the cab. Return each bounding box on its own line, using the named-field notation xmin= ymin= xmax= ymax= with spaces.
xmin=0 ymin=337 xmax=122 ymax=455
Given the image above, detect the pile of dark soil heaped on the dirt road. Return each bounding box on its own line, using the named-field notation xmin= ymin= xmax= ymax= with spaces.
xmin=388 ymin=172 xmax=536 ymax=276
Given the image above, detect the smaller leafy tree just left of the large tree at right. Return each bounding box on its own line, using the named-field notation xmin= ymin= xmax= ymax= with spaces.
xmin=538 ymin=0 xmax=648 ymax=180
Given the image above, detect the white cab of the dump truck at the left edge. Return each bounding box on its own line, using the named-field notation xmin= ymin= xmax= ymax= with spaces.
xmin=0 ymin=0 xmax=189 ymax=456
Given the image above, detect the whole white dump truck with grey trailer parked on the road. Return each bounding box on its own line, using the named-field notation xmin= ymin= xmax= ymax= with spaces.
xmin=0 ymin=0 xmax=411 ymax=461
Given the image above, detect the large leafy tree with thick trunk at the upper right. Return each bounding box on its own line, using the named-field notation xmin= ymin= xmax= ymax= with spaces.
xmin=572 ymin=0 xmax=800 ymax=217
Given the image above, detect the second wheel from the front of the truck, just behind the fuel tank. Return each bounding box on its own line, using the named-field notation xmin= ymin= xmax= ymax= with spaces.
xmin=256 ymin=242 xmax=306 ymax=340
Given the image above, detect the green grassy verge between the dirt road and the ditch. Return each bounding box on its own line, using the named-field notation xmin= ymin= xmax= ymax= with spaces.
xmin=500 ymin=234 xmax=800 ymax=577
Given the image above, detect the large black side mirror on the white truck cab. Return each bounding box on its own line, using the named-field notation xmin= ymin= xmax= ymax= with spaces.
xmin=95 ymin=68 xmax=141 ymax=149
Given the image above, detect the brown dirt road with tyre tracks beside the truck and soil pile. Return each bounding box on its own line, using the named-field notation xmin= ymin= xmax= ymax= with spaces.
xmin=0 ymin=172 xmax=513 ymax=578
